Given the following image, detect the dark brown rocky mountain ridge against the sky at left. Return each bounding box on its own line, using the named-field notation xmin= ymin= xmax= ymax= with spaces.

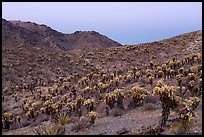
xmin=2 ymin=19 xmax=122 ymax=51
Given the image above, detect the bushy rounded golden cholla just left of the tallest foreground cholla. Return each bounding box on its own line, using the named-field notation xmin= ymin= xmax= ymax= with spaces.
xmin=131 ymin=86 xmax=147 ymax=107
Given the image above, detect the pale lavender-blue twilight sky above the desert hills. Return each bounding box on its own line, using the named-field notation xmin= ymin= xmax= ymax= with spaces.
xmin=2 ymin=2 xmax=202 ymax=44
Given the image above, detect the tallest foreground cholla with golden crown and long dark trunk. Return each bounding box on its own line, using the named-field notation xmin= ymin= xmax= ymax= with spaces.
xmin=153 ymin=81 xmax=179 ymax=126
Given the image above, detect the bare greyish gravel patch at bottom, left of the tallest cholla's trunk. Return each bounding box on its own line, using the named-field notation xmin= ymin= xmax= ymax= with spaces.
xmin=66 ymin=107 xmax=161 ymax=135
